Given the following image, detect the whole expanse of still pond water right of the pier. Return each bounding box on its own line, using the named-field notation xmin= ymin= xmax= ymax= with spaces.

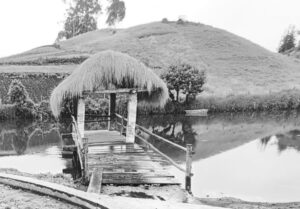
xmin=138 ymin=112 xmax=300 ymax=202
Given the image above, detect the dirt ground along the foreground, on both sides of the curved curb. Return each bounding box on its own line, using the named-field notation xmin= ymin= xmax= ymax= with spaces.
xmin=0 ymin=169 xmax=300 ymax=209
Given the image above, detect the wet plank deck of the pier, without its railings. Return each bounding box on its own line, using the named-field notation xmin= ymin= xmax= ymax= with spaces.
xmin=85 ymin=130 xmax=179 ymax=187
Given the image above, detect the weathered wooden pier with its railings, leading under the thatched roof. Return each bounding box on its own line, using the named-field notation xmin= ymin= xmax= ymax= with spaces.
xmin=72 ymin=114 xmax=192 ymax=193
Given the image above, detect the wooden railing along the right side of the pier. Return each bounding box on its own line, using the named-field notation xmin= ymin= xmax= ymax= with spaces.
xmin=115 ymin=114 xmax=193 ymax=192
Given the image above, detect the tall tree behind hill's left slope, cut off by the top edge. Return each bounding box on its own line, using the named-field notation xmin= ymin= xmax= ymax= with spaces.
xmin=56 ymin=0 xmax=125 ymax=41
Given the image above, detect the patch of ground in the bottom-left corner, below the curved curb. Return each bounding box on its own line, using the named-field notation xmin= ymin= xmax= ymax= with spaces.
xmin=0 ymin=184 xmax=79 ymax=209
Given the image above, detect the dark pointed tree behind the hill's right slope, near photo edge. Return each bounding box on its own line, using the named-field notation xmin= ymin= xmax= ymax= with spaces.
xmin=278 ymin=26 xmax=296 ymax=53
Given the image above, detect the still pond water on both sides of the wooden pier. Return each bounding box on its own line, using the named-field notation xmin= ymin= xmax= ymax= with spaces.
xmin=0 ymin=113 xmax=300 ymax=202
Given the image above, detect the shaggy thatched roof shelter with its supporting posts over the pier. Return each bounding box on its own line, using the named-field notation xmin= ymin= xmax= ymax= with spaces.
xmin=50 ymin=51 xmax=168 ymax=142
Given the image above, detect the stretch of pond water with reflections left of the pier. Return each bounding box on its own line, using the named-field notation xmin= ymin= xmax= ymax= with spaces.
xmin=0 ymin=121 xmax=67 ymax=174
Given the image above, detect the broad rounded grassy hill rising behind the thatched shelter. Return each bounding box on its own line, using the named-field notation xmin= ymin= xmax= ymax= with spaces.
xmin=0 ymin=22 xmax=300 ymax=106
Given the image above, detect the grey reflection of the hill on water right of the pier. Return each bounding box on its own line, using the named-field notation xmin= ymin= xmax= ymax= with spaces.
xmin=138 ymin=112 xmax=300 ymax=162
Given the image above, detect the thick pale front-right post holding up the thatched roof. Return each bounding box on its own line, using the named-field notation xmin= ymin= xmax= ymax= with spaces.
xmin=126 ymin=91 xmax=137 ymax=143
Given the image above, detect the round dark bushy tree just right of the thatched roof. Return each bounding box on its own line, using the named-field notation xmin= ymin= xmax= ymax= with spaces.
xmin=162 ymin=63 xmax=206 ymax=103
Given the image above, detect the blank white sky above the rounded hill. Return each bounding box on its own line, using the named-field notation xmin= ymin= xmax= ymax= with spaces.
xmin=0 ymin=0 xmax=300 ymax=57
